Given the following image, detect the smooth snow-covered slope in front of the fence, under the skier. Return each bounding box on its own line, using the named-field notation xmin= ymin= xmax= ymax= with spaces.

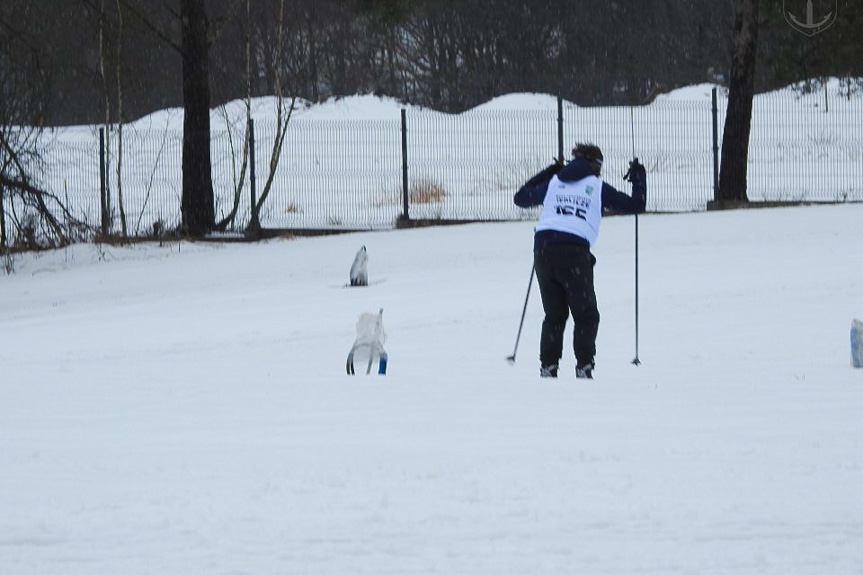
xmin=0 ymin=205 xmax=863 ymax=575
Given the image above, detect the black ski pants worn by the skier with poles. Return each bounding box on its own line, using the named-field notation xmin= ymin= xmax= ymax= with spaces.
xmin=534 ymin=243 xmax=599 ymax=366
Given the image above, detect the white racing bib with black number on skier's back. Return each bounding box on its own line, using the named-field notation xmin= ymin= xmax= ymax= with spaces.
xmin=536 ymin=176 xmax=602 ymax=246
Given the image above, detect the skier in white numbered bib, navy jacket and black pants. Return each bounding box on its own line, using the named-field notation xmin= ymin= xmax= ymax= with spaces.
xmin=514 ymin=143 xmax=647 ymax=379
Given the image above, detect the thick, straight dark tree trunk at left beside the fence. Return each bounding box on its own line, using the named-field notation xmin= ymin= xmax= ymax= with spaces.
xmin=180 ymin=0 xmax=216 ymax=236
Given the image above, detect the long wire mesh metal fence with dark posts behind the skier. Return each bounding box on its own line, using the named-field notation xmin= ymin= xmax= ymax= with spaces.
xmin=13 ymin=90 xmax=863 ymax=235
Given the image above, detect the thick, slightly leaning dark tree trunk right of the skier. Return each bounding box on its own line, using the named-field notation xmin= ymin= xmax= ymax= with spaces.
xmin=715 ymin=0 xmax=759 ymax=202
